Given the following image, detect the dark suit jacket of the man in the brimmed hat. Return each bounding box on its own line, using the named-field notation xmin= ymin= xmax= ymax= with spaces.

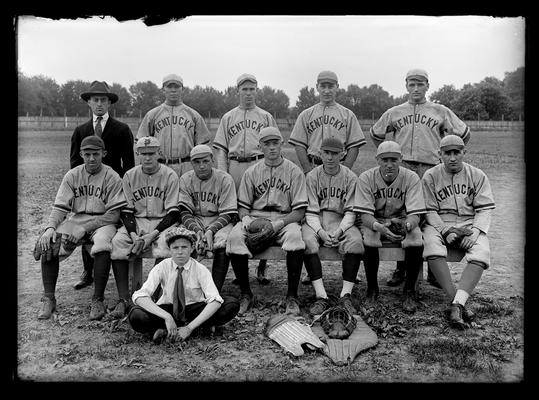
xmin=70 ymin=115 xmax=135 ymax=177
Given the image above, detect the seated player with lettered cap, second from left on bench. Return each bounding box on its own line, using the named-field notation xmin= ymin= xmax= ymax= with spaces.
xmin=111 ymin=136 xmax=180 ymax=318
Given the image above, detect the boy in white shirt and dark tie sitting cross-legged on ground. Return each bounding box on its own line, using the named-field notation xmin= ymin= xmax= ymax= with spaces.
xmin=128 ymin=226 xmax=239 ymax=343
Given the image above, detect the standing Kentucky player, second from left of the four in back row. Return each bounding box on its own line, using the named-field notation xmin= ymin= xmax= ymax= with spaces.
xmin=212 ymin=74 xmax=277 ymax=284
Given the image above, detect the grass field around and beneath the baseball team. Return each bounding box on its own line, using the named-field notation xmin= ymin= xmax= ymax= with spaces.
xmin=14 ymin=131 xmax=526 ymax=382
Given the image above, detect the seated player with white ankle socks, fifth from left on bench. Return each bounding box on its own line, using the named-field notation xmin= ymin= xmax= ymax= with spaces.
xmin=301 ymin=137 xmax=364 ymax=315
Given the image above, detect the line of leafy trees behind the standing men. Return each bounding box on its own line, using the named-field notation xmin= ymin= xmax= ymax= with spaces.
xmin=18 ymin=67 xmax=524 ymax=120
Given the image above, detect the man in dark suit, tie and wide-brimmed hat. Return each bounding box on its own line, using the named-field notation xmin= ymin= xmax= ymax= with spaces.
xmin=70 ymin=81 xmax=135 ymax=289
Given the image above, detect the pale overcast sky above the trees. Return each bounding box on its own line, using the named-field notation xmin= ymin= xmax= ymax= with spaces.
xmin=17 ymin=16 xmax=525 ymax=106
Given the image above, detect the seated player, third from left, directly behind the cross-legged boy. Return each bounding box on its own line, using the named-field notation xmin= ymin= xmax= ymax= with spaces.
xmin=179 ymin=144 xmax=238 ymax=292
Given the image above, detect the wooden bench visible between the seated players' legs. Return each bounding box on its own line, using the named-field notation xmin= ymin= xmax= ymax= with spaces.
xmin=129 ymin=242 xmax=464 ymax=293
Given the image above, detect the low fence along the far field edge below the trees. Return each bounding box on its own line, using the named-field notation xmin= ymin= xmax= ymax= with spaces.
xmin=18 ymin=116 xmax=524 ymax=134
